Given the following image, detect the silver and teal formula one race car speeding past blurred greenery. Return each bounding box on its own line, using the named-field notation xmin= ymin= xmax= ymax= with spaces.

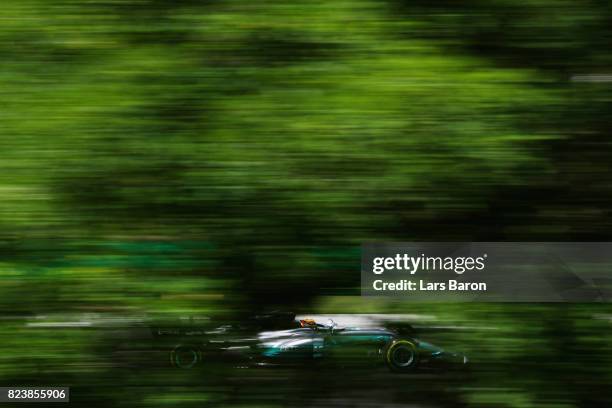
xmin=158 ymin=313 xmax=468 ymax=372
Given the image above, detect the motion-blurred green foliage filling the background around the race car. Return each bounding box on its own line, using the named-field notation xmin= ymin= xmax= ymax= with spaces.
xmin=0 ymin=0 xmax=612 ymax=407
